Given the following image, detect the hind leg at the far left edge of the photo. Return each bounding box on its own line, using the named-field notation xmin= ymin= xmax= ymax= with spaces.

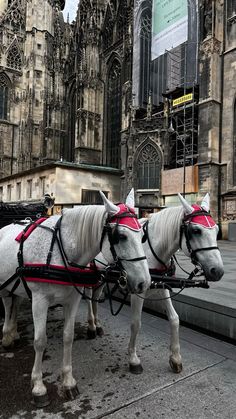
xmin=2 ymin=295 xmax=20 ymax=348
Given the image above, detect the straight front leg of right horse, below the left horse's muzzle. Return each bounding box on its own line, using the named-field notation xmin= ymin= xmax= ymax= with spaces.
xmin=128 ymin=294 xmax=145 ymax=374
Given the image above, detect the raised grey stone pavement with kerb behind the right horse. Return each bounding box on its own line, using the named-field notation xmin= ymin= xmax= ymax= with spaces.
xmin=142 ymin=241 xmax=236 ymax=341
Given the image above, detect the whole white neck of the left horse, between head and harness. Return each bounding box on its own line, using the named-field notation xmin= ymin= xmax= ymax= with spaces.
xmin=62 ymin=205 xmax=106 ymax=265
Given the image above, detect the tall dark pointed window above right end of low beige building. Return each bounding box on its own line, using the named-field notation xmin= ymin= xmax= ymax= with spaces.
xmin=106 ymin=59 xmax=121 ymax=168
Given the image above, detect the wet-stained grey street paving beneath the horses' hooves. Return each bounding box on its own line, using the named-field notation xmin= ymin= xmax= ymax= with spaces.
xmin=0 ymin=300 xmax=236 ymax=419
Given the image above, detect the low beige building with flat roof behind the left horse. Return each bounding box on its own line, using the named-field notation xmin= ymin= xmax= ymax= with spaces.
xmin=0 ymin=163 xmax=121 ymax=206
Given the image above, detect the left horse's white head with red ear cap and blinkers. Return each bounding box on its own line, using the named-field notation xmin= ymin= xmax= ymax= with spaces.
xmin=100 ymin=192 xmax=151 ymax=293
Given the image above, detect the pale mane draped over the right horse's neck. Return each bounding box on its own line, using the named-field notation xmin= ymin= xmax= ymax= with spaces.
xmin=149 ymin=206 xmax=184 ymax=257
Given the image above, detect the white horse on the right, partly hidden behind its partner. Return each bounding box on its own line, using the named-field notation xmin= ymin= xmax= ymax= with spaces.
xmin=84 ymin=191 xmax=224 ymax=374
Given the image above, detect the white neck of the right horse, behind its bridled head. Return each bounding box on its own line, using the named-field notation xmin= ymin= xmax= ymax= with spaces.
xmin=147 ymin=207 xmax=183 ymax=264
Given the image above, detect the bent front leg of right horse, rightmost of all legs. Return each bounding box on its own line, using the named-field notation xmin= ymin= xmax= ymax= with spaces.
xmin=161 ymin=290 xmax=183 ymax=373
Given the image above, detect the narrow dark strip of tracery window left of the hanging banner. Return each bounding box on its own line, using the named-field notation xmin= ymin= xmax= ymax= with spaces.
xmin=139 ymin=8 xmax=152 ymax=104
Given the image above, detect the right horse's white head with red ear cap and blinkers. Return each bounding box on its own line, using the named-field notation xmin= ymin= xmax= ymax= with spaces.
xmin=179 ymin=193 xmax=224 ymax=281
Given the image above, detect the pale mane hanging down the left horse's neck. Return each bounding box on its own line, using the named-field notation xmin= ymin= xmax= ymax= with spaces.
xmin=63 ymin=205 xmax=106 ymax=255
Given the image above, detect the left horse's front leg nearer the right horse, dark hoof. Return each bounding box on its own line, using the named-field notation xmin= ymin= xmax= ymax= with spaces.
xmin=62 ymin=292 xmax=81 ymax=400
